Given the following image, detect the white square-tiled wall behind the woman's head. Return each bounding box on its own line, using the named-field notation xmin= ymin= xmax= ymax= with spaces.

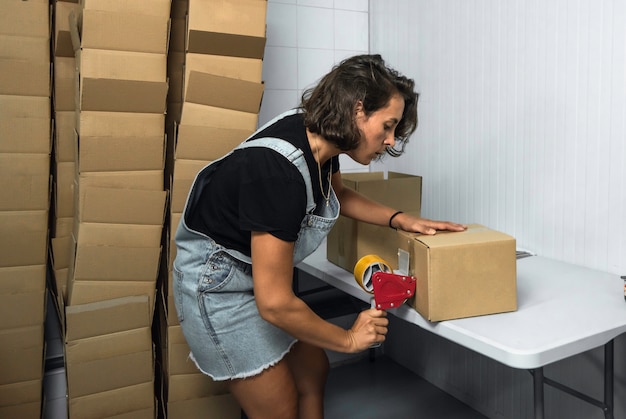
xmin=259 ymin=0 xmax=369 ymax=172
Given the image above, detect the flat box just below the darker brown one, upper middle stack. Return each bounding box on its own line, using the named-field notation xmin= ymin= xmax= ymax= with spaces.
xmin=76 ymin=111 xmax=165 ymax=138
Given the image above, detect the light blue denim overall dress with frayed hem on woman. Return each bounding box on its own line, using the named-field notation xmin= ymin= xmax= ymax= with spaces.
xmin=173 ymin=111 xmax=339 ymax=381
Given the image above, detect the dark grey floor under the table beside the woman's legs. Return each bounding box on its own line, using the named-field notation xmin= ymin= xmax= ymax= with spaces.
xmin=325 ymin=356 xmax=486 ymax=419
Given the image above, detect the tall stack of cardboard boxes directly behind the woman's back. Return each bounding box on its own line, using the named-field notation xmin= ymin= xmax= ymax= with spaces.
xmin=159 ymin=0 xmax=267 ymax=418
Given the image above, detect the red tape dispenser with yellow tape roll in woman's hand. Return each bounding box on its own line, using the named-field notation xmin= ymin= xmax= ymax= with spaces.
xmin=354 ymin=255 xmax=415 ymax=310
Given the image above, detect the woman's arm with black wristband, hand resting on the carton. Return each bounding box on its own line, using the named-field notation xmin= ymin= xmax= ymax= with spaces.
xmin=332 ymin=171 xmax=467 ymax=235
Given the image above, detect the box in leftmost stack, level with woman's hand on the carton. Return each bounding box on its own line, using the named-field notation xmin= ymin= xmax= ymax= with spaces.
xmin=0 ymin=210 xmax=48 ymax=267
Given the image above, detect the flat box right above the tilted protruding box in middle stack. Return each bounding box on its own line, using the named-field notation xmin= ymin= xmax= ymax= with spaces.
xmin=67 ymin=280 xmax=156 ymax=309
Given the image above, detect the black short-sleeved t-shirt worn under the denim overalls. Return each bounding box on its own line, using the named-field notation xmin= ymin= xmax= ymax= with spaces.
xmin=186 ymin=114 xmax=339 ymax=256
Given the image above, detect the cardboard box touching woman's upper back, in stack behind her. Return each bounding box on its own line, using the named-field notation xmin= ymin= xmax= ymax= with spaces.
xmin=176 ymin=125 xmax=254 ymax=161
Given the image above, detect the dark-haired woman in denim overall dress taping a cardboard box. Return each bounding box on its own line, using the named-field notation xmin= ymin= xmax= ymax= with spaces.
xmin=173 ymin=55 xmax=465 ymax=419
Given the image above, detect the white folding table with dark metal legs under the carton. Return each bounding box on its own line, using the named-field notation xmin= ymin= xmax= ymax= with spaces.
xmin=297 ymin=243 xmax=626 ymax=419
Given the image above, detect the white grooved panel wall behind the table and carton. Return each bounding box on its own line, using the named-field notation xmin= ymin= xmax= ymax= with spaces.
xmin=370 ymin=0 xmax=626 ymax=419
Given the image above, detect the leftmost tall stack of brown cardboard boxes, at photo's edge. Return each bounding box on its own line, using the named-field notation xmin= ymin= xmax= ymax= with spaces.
xmin=0 ymin=0 xmax=51 ymax=417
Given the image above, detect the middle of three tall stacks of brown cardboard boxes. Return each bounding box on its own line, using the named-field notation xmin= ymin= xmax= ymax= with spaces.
xmin=54 ymin=0 xmax=170 ymax=418
